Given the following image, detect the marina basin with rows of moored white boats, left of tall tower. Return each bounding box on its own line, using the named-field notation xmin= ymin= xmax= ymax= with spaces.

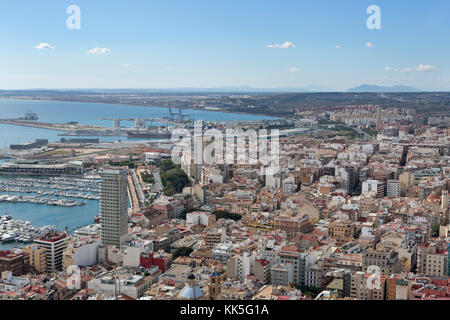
xmin=0 ymin=176 xmax=100 ymax=249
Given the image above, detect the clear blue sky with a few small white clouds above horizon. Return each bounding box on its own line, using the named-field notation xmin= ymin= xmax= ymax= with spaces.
xmin=0 ymin=0 xmax=450 ymax=90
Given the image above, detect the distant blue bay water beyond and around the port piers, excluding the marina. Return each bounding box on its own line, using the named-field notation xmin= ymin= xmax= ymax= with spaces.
xmin=0 ymin=99 xmax=273 ymax=148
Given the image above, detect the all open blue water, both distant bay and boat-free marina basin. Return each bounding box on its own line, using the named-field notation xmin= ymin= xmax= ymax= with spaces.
xmin=0 ymin=100 xmax=274 ymax=249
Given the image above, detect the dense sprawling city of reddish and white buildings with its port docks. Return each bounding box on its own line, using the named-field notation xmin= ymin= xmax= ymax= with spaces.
xmin=0 ymin=101 xmax=450 ymax=300
